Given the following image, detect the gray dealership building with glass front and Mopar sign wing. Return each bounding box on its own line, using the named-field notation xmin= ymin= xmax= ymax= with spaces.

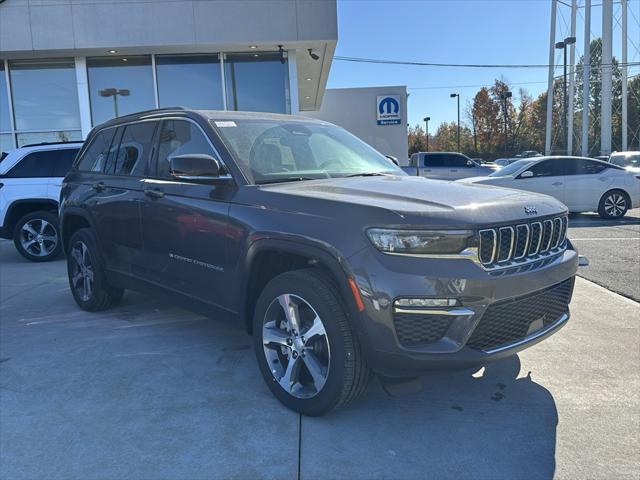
xmin=0 ymin=0 xmax=406 ymax=160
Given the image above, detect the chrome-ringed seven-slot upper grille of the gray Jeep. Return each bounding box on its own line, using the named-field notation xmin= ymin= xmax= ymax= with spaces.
xmin=478 ymin=215 xmax=568 ymax=268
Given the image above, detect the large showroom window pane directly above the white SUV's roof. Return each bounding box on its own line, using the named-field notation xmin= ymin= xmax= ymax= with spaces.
xmin=9 ymin=59 xmax=80 ymax=131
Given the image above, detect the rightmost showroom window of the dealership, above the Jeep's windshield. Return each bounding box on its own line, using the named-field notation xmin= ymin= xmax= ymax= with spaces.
xmin=224 ymin=53 xmax=288 ymax=113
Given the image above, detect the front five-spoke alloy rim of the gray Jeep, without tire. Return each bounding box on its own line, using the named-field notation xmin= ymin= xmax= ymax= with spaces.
xmin=262 ymin=293 xmax=331 ymax=399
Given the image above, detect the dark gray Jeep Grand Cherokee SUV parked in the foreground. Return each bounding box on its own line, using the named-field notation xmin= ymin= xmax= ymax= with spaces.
xmin=60 ymin=108 xmax=578 ymax=415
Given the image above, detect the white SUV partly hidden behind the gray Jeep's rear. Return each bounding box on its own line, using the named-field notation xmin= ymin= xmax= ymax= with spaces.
xmin=0 ymin=143 xmax=82 ymax=262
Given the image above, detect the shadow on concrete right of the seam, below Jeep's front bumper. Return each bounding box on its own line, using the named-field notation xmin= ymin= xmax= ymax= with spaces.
xmin=301 ymin=356 xmax=558 ymax=479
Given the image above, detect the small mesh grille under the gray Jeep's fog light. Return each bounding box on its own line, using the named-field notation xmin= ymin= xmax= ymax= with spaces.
xmin=393 ymin=313 xmax=456 ymax=347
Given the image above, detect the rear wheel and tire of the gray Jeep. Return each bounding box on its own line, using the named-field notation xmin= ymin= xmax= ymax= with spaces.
xmin=67 ymin=228 xmax=124 ymax=312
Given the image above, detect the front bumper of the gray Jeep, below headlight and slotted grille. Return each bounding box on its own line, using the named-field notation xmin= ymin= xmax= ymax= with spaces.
xmin=349 ymin=244 xmax=578 ymax=376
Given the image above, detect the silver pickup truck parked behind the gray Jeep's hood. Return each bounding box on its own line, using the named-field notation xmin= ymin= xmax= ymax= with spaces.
xmin=402 ymin=152 xmax=498 ymax=180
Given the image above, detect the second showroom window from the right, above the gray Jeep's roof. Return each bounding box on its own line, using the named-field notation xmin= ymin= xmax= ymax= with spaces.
xmin=156 ymin=55 xmax=223 ymax=110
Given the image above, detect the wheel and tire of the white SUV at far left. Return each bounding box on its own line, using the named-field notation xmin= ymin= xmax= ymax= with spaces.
xmin=13 ymin=211 xmax=62 ymax=262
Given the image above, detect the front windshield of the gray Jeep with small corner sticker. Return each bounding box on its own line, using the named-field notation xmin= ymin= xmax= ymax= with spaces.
xmin=211 ymin=119 xmax=406 ymax=184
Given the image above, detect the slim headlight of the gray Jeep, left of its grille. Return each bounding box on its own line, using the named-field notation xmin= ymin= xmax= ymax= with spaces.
xmin=367 ymin=228 xmax=474 ymax=255
